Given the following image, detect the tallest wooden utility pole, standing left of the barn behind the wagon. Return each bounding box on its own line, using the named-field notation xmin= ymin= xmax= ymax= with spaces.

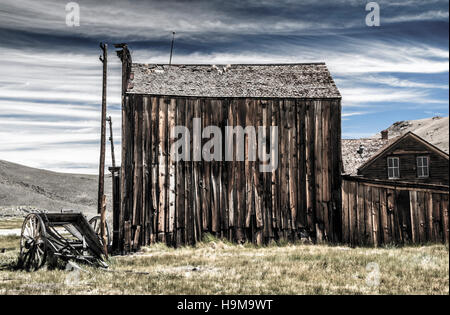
xmin=97 ymin=43 xmax=108 ymax=214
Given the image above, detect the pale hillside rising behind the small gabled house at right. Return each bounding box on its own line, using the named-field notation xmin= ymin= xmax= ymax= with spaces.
xmin=374 ymin=116 xmax=449 ymax=153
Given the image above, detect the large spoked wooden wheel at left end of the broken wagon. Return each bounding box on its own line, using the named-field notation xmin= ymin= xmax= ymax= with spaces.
xmin=19 ymin=214 xmax=47 ymax=271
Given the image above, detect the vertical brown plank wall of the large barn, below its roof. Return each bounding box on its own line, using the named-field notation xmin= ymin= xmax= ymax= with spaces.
xmin=117 ymin=93 xmax=341 ymax=251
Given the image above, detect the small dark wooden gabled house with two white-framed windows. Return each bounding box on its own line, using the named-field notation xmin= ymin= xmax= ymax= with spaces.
xmin=358 ymin=132 xmax=449 ymax=186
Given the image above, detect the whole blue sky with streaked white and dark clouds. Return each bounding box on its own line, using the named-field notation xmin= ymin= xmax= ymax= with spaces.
xmin=0 ymin=0 xmax=449 ymax=173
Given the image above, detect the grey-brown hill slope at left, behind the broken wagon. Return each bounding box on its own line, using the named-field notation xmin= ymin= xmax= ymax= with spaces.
xmin=0 ymin=160 xmax=111 ymax=215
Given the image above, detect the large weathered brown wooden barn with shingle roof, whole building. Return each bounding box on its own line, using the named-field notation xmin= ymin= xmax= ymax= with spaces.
xmin=114 ymin=46 xmax=342 ymax=251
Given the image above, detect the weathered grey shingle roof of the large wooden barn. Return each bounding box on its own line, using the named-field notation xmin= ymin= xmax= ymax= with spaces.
xmin=127 ymin=63 xmax=341 ymax=98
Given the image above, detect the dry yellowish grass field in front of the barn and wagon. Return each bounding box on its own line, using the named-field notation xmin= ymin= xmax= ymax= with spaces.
xmin=0 ymin=236 xmax=449 ymax=295
